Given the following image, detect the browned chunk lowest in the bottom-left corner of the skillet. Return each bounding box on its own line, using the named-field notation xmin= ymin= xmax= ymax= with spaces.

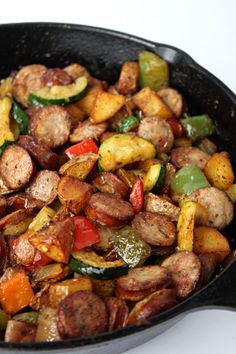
xmin=4 ymin=320 xmax=37 ymax=343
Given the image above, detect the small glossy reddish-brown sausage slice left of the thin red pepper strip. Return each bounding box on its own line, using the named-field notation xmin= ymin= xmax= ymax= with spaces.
xmin=93 ymin=172 xmax=129 ymax=199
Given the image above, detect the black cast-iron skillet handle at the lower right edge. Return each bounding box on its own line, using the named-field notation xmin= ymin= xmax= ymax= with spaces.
xmin=191 ymin=260 xmax=236 ymax=310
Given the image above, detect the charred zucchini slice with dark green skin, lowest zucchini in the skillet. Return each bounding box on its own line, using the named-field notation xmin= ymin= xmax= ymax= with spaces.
xmin=69 ymin=249 xmax=129 ymax=280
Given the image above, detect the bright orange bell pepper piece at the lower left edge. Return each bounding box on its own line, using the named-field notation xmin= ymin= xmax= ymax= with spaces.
xmin=0 ymin=269 xmax=34 ymax=315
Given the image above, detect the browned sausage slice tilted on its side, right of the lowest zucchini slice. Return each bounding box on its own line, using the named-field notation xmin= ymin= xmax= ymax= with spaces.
xmin=116 ymin=265 xmax=171 ymax=291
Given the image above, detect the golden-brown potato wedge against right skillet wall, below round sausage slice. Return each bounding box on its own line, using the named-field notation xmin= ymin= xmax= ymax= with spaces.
xmin=193 ymin=226 xmax=230 ymax=262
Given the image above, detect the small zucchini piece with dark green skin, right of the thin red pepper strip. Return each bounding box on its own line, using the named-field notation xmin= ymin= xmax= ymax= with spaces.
xmin=143 ymin=163 xmax=166 ymax=194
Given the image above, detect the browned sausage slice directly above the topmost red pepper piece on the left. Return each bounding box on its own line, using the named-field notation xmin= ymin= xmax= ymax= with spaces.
xmin=70 ymin=119 xmax=107 ymax=143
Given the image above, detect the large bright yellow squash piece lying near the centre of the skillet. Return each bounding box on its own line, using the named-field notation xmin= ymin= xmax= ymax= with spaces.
xmin=98 ymin=134 xmax=156 ymax=171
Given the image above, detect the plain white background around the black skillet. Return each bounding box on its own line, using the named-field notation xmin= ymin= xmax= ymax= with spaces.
xmin=0 ymin=0 xmax=236 ymax=354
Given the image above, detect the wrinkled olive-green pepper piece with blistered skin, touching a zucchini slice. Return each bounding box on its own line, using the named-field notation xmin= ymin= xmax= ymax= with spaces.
xmin=110 ymin=226 xmax=151 ymax=267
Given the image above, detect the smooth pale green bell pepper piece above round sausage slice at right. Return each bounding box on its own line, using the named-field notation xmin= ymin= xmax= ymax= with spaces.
xmin=170 ymin=164 xmax=209 ymax=195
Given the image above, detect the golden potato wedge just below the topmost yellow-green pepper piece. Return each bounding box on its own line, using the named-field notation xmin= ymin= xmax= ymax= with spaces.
xmin=133 ymin=87 xmax=174 ymax=119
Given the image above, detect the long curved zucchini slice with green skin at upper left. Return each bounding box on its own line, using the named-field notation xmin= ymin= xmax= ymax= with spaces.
xmin=28 ymin=76 xmax=88 ymax=107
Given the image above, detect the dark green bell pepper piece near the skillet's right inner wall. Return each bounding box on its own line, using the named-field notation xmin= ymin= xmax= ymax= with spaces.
xmin=181 ymin=114 xmax=215 ymax=141
